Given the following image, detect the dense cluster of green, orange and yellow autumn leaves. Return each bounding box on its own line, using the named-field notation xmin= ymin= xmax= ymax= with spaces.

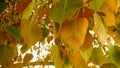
xmin=0 ymin=0 xmax=120 ymax=68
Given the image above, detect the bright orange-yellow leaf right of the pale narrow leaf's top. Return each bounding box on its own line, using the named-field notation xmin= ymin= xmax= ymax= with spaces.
xmin=103 ymin=11 xmax=115 ymax=26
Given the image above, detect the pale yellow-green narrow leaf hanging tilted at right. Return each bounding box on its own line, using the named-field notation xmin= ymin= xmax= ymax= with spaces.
xmin=94 ymin=13 xmax=107 ymax=44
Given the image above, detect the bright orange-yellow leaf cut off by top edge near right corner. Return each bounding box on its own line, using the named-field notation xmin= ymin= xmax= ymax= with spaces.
xmin=106 ymin=0 xmax=118 ymax=11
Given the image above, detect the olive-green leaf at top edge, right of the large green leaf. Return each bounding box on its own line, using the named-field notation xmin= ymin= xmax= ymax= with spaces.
xmin=89 ymin=0 xmax=105 ymax=12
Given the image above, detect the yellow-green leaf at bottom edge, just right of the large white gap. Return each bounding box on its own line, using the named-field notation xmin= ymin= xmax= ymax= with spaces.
xmin=51 ymin=45 xmax=64 ymax=68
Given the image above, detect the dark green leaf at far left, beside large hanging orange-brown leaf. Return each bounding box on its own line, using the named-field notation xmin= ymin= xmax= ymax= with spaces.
xmin=6 ymin=26 xmax=22 ymax=41
